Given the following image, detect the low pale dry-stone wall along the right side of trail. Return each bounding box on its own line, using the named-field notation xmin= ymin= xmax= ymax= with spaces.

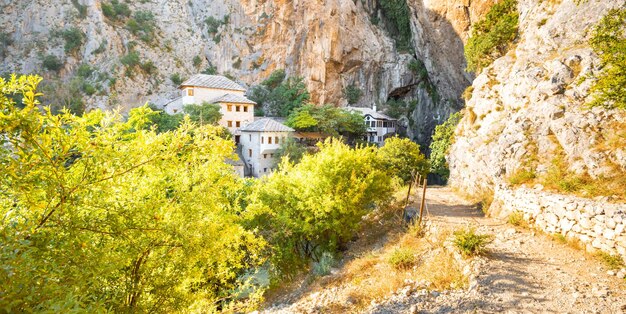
xmin=489 ymin=186 xmax=626 ymax=261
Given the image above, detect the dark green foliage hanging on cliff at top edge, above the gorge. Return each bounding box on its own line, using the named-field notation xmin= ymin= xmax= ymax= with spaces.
xmin=378 ymin=0 xmax=413 ymax=51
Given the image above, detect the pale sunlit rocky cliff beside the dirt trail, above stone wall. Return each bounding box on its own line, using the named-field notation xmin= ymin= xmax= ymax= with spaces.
xmin=448 ymin=0 xmax=626 ymax=194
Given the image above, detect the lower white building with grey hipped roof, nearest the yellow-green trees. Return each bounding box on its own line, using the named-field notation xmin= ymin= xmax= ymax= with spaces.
xmin=240 ymin=118 xmax=294 ymax=178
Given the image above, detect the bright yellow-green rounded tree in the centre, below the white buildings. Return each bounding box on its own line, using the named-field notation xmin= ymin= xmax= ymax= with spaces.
xmin=244 ymin=140 xmax=393 ymax=274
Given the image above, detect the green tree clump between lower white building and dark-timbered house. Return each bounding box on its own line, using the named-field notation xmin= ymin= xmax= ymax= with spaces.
xmin=285 ymin=104 xmax=367 ymax=140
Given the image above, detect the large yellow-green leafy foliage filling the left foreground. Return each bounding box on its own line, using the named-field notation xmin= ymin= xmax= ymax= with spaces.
xmin=0 ymin=76 xmax=265 ymax=312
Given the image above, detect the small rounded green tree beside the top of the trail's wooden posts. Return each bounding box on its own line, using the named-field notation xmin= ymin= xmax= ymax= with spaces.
xmin=378 ymin=136 xmax=429 ymax=183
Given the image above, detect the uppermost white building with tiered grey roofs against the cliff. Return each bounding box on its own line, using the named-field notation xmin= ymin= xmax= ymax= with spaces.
xmin=163 ymin=74 xmax=256 ymax=143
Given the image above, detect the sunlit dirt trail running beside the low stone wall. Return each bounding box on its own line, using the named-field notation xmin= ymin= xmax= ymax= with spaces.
xmin=260 ymin=187 xmax=626 ymax=313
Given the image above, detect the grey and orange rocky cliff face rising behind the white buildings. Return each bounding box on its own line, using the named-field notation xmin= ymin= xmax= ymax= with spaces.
xmin=0 ymin=0 xmax=493 ymax=144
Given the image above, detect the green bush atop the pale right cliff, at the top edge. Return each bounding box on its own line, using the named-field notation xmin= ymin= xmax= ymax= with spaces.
xmin=465 ymin=0 xmax=519 ymax=72
